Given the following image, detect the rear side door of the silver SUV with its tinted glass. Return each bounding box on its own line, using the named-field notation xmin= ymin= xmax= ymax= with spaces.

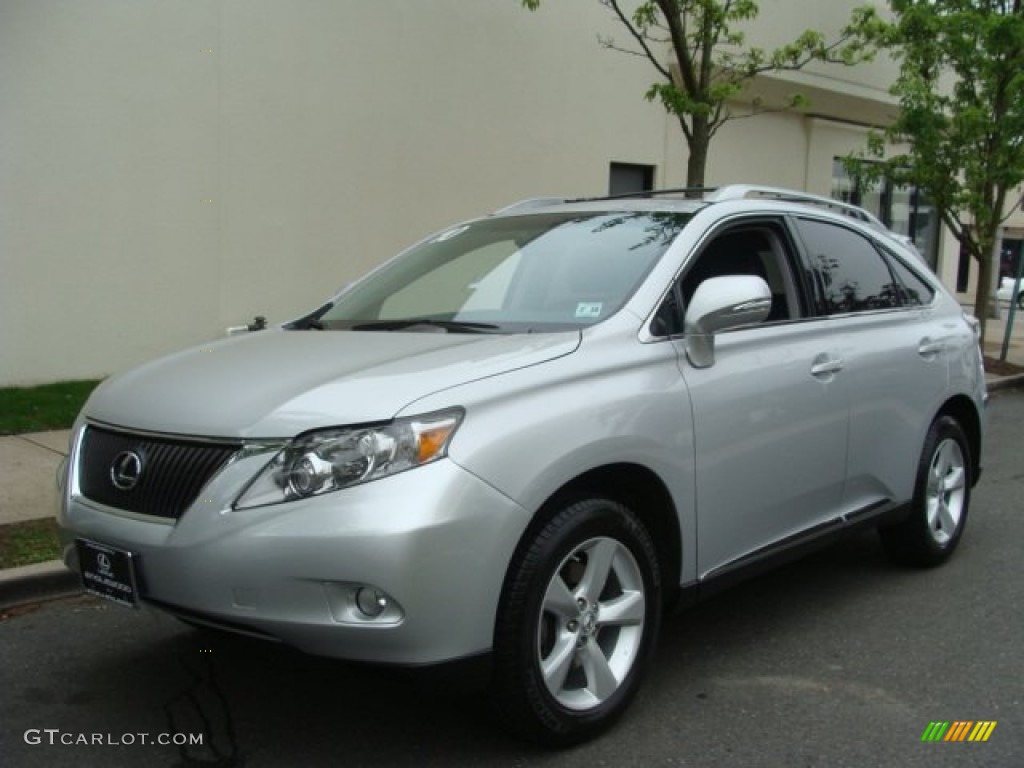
xmin=794 ymin=216 xmax=954 ymax=516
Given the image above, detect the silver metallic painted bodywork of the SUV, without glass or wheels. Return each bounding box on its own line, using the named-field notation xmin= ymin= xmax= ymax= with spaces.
xmin=59 ymin=201 xmax=985 ymax=664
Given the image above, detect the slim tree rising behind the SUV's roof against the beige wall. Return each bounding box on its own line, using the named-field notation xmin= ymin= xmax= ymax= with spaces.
xmin=522 ymin=0 xmax=878 ymax=186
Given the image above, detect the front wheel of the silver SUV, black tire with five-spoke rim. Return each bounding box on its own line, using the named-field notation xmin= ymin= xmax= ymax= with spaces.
xmin=494 ymin=499 xmax=662 ymax=746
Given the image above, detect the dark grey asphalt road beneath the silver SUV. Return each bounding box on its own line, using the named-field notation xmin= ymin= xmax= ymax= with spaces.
xmin=0 ymin=394 xmax=1024 ymax=768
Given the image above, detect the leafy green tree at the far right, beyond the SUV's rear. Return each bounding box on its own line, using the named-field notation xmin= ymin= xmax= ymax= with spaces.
xmin=849 ymin=0 xmax=1024 ymax=340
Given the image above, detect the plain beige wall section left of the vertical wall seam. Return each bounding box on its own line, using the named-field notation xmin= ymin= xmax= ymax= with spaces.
xmin=0 ymin=0 xmax=219 ymax=385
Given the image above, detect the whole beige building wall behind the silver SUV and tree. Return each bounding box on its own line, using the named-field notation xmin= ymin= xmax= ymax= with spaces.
xmin=0 ymin=0 xmax=921 ymax=385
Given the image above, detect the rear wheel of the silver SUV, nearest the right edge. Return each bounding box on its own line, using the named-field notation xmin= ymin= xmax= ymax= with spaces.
xmin=879 ymin=416 xmax=974 ymax=567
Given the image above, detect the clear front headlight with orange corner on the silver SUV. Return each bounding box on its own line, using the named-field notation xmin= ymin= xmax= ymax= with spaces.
xmin=234 ymin=409 xmax=463 ymax=509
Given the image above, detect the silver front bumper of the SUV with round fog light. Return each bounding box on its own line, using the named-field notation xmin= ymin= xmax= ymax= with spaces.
xmin=57 ymin=438 xmax=528 ymax=665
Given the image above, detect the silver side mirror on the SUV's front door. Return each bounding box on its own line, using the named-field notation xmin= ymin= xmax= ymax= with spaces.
xmin=683 ymin=274 xmax=771 ymax=368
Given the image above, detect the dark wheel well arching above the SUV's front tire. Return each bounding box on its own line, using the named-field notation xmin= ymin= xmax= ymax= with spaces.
xmin=523 ymin=464 xmax=682 ymax=605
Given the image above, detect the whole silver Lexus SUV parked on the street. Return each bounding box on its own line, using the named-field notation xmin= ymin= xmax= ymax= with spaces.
xmin=59 ymin=186 xmax=986 ymax=745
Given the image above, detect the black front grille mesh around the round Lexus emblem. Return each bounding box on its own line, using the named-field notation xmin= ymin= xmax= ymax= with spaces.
xmin=79 ymin=426 xmax=241 ymax=520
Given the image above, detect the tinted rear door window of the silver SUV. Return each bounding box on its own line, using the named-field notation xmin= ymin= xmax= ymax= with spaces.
xmin=798 ymin=219 xmax=901 ymax=314
